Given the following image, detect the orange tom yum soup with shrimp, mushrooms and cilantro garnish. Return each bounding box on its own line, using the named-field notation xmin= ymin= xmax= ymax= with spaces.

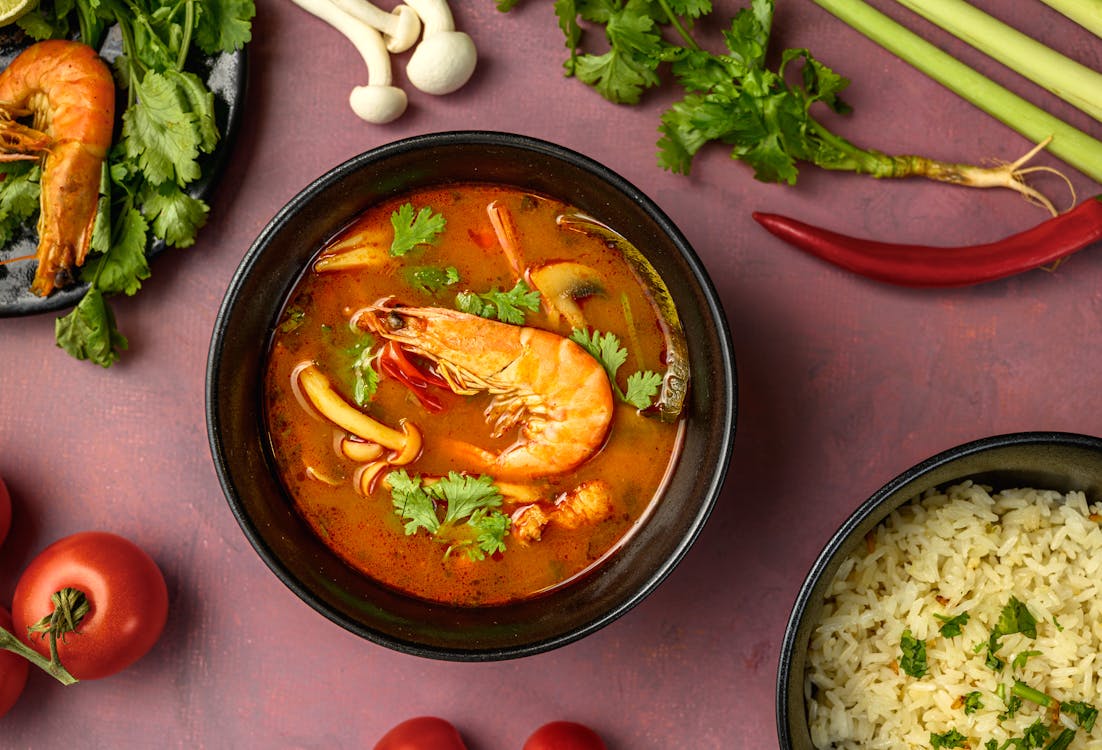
xmin=266 ymin=184 xmax=688 ymax=606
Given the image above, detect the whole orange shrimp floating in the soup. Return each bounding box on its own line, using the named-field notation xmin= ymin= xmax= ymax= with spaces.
xmin=353 ymin=304 xmax=613 ymax=478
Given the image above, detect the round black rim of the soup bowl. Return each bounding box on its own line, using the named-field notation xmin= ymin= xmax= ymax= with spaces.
xmin=205 ymin=130 xmax=737 ymax=662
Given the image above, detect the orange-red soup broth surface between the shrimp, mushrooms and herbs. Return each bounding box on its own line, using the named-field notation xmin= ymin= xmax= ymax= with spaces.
xmin=266 ymin=185 xmax=680 ymax=606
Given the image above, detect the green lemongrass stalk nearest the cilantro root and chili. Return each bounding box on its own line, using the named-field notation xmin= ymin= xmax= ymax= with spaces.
xmin=814 ymin=0 xmax=1102 ymax=182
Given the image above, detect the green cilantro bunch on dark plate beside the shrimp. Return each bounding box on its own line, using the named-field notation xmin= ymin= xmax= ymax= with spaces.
xmin=0 ymin=0 xmax=256 ymax=367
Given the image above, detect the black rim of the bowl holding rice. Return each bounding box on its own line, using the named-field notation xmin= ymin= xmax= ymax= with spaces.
xmin=775 ymin=431 xmax=1102 ymax=750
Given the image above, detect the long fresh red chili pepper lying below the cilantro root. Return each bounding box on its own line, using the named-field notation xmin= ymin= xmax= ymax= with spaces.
xmin=753 ymin=196 xmax=1102 ymax=286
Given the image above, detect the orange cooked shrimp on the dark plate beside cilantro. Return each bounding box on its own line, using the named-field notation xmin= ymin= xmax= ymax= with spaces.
xmin=0 ymin=40 xmax=115 ymax=296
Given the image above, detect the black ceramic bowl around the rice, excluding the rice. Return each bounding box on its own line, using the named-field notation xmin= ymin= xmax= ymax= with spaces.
xmin=777 ymin=432 xmax=1102 ymax=750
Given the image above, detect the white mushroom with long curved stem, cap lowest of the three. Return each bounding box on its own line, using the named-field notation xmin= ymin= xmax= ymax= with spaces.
xmin=294 ymin=0 xmax=408 ymax=124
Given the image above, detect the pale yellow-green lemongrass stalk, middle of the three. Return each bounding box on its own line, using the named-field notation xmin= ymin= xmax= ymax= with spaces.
xmin=896 ymin=0 xmax=1102 ymax=121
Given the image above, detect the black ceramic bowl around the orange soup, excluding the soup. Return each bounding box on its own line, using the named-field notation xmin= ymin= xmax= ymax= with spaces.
xmin=206 ymin=132 xmax=736 ymax=661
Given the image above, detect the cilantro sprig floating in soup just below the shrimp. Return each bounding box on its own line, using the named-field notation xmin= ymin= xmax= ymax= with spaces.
xmin=387 ymin=469 xmax=509 ymax=561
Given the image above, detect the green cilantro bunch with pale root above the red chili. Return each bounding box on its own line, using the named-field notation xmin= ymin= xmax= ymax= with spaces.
xmin=497 ymin=0 xmax=1030 ymax=195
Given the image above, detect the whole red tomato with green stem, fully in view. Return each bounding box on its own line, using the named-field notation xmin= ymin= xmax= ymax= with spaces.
xmin=11 ymin=531 xmax=169 ymax=680
